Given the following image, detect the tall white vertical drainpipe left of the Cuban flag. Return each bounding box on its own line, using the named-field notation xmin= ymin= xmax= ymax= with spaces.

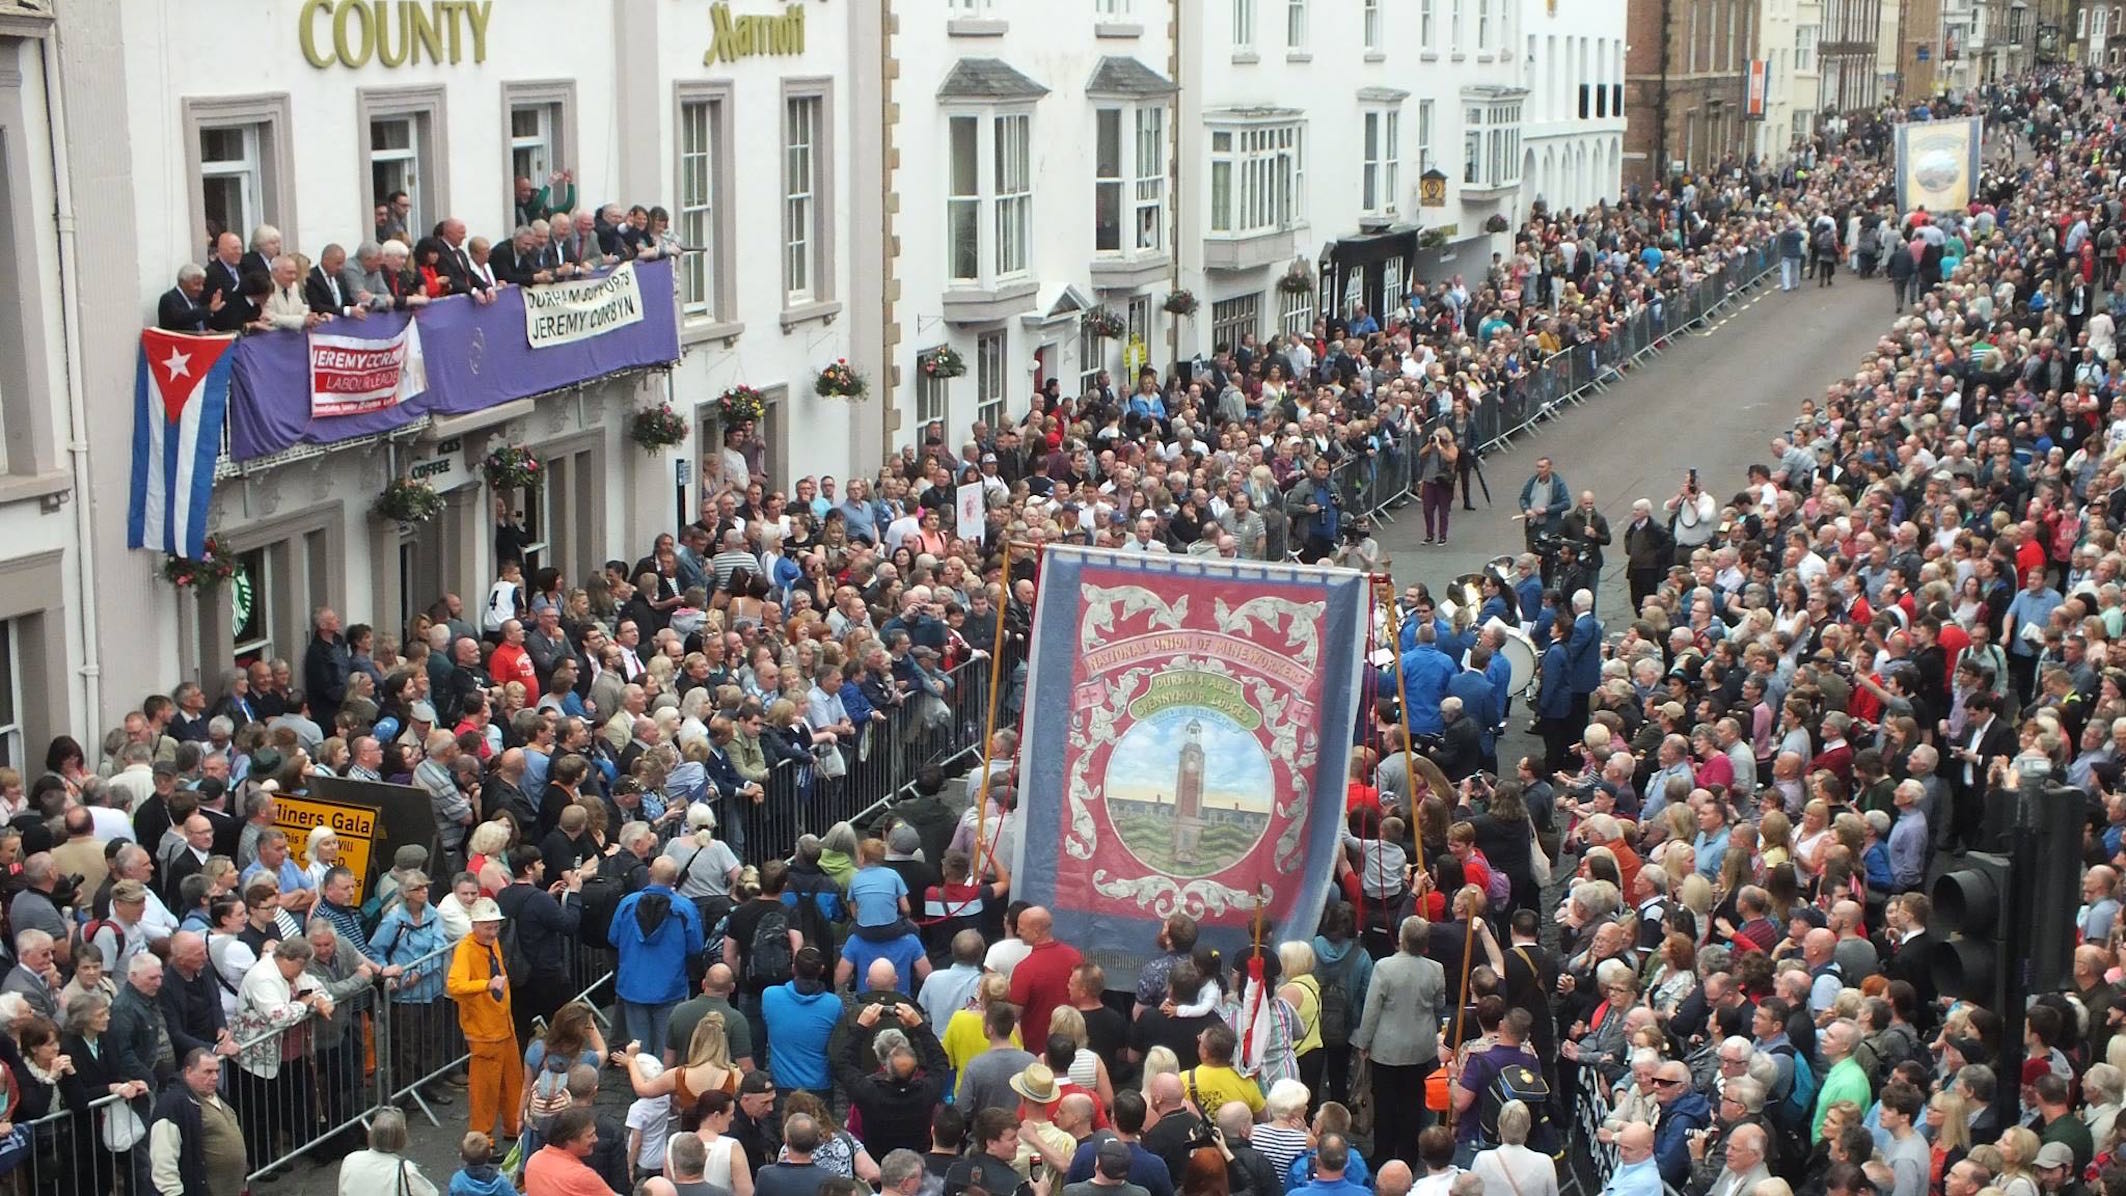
xmin=43 ymin=30 xmax=104 ymax=744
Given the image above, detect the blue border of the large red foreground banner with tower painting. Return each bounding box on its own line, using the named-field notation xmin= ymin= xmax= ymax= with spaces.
xmin=1012 ymin=546 xmax=1369 ymax=988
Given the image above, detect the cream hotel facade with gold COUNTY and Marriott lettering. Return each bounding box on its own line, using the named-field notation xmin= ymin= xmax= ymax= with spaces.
xmin=47 ymin=0 xmax=861 ymax=729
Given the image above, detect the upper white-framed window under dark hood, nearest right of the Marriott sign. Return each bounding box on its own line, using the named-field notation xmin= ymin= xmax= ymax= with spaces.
xmin=944 ymin=113 xmax=1033 ymax=283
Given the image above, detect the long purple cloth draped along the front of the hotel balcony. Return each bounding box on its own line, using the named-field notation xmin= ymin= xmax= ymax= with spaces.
xmin=230 ymin=259 xmax=678 ymax=461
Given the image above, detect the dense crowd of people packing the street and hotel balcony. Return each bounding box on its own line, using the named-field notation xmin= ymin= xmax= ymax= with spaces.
xmin=70 ymin=49 xmax=2126 ymax=1196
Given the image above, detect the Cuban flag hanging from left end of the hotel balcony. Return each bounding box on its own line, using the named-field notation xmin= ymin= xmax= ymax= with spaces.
xmin=125 ymin=327 xmax=236 ymax=559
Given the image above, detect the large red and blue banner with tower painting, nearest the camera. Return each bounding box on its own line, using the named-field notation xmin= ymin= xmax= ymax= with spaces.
xmin=1012 ymin=546 xmax=1367 ymax=988
